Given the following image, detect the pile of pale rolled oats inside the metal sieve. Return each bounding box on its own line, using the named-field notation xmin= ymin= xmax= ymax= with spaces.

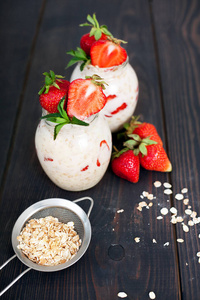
xmin=17 ymin=216 xmax=81 ymax=266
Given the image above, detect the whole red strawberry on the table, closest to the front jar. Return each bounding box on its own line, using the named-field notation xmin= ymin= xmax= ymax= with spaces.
xmin=111 ymin=148 xmax=140 ymax=183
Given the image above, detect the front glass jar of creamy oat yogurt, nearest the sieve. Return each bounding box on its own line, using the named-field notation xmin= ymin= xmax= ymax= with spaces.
xmin=35 ymin=114 xmax=112 ymax=191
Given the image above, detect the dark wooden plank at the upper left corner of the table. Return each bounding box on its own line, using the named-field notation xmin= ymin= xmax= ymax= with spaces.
xmin=0 ymin=0 xmax=42 ymax=185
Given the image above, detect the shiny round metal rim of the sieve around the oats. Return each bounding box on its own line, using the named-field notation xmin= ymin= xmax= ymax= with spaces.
xmin=11 ymin=197 xmax=92 ymax=272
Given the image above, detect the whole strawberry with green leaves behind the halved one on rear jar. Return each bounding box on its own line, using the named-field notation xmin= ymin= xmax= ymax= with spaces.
xmin=80 ymin=14 xmax=112 ymax=56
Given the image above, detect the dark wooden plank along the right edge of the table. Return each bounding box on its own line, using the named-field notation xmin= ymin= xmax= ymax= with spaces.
xmin=152 ymin=0 xmax=200 ymax=299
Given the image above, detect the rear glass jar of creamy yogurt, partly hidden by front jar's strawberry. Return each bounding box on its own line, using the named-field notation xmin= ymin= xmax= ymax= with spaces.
xmin=70 ymin=58 xmax=139 ymax=132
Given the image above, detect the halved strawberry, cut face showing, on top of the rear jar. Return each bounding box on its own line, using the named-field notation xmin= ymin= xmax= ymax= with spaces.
xmin=90 ymin=38 xmax=127 ymax=68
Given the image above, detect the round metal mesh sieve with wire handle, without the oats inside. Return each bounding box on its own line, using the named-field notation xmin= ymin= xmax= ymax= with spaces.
xmin=0 ymin=197 xmax=94 ymax=296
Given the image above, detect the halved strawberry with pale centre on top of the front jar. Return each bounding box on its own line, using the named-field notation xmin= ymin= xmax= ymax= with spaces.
xmin=67 ymin=75 xmax=106 ymax=120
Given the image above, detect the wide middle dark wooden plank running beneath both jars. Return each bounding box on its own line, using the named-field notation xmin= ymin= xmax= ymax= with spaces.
xmin=0 ymin=0 xmax=179 ymax=300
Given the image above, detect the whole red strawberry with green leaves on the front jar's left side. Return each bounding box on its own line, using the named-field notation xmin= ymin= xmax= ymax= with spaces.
xmin=38 ymin=70 xmax=69 ymax=113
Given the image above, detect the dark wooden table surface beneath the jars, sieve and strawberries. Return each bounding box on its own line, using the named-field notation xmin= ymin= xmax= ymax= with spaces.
xmin=0 ymin=0 xmax=200 ymax=300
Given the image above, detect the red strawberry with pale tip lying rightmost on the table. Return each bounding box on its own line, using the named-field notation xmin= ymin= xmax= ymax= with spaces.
xmin=139 ymin=144 xmax=172 ymax=172
